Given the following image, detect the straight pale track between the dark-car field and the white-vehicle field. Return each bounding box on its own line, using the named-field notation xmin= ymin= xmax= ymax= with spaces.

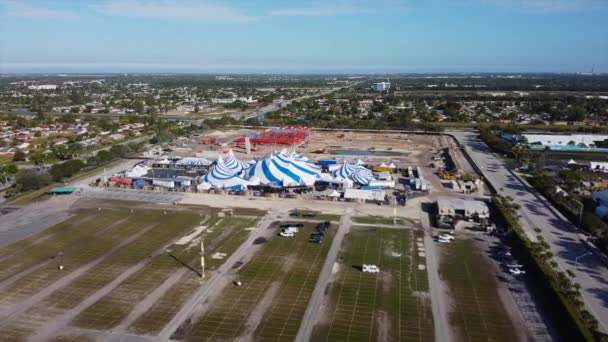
xmin=295 ymin=208 xmax=353 ymax=342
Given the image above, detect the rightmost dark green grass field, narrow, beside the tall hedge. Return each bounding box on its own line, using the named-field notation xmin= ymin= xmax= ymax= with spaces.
xmin=439 ymin=240 xmax=518 ymax=342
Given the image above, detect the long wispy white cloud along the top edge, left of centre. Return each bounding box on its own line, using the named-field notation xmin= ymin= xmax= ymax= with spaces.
xmin=92 ymin=0 xmax=256 ymax=23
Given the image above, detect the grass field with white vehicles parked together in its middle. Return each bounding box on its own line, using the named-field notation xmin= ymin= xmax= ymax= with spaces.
xmin=311 ymin=226 xmax=433 ymax=341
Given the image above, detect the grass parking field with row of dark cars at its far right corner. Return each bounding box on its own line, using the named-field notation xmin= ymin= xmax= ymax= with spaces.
xmin=188 ymin=223 xmax=335 ymax=341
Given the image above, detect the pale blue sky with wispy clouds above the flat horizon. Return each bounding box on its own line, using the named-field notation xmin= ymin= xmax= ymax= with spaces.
xmin=0 ymin=0 xmax=608 ymax=73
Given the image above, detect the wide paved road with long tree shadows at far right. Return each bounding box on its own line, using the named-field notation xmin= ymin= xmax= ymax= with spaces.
xmin=450 ymin=131 xmax=608 ymax=334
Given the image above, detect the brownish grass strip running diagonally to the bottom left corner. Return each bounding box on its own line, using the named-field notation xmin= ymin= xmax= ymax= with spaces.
xmin=0 ymin=210 xmax=200 ymax=340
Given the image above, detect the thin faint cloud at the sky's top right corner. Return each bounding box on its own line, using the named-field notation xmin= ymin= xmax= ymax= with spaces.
xmin=480 ymin=0 xmax=608 ymax=12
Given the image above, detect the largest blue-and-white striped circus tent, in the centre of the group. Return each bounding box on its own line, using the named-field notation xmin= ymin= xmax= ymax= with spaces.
xmin=249 ymin=151 xmax=321 ymax=186
